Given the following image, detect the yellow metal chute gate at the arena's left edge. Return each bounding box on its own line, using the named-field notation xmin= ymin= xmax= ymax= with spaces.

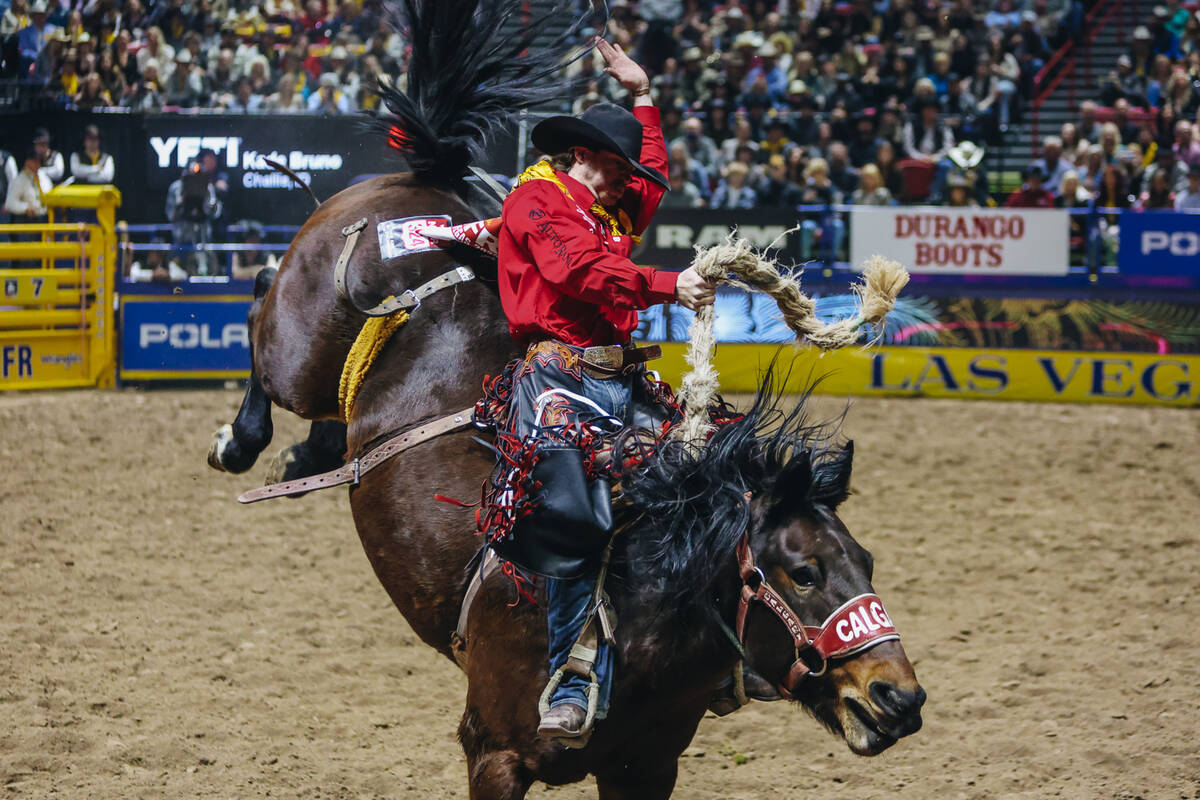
xmin=0 ymin=186 xmax=121 ymax=390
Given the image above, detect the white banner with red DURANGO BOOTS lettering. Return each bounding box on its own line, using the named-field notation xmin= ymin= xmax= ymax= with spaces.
xmin=850 ymin=206 xmax=1070 ymax=275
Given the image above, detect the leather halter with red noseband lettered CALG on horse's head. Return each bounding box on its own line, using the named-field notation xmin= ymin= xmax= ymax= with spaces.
xmin=734 ymin=531 xmax=900 ymax=699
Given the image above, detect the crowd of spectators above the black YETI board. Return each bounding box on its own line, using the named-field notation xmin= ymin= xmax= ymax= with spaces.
xmin=0 ymin=0 xmax=404 ymax=114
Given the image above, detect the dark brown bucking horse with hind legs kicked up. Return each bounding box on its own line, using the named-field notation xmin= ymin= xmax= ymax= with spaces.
xmin=209 ymin=0 xmax=925 ymax=800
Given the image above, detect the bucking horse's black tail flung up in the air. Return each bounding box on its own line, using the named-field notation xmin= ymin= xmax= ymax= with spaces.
xmin=374 ymin=0 xmax=595 ymax=184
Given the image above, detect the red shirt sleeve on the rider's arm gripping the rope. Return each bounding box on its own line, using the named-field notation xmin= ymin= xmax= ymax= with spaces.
xmin=504 ymin=181 xmax=678 ymax=311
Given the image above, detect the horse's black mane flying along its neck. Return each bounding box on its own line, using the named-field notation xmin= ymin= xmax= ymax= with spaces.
xmin=620 ymin=368 xmax=852 ymax=609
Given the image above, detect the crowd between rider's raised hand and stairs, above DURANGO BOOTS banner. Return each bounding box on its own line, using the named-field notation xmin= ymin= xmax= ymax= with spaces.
xmin=572 ymin=0 xmax=1082 ymax=227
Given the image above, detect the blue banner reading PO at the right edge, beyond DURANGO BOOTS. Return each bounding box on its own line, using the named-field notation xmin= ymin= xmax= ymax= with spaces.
xmin=1117 ymin=211 xmax=1200 ymax=277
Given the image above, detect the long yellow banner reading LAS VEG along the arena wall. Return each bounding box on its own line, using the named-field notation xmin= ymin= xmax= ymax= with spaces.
xmin=655 ymin=344 xmax=1200 ymax=407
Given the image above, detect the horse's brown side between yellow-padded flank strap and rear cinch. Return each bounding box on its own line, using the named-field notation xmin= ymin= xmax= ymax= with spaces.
xmin=347 ymin=281 xmax=516 ymax=452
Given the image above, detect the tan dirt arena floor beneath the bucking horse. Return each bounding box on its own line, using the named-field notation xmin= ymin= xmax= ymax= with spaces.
xmin=0 ymin=391 xmax=1200 ymax=800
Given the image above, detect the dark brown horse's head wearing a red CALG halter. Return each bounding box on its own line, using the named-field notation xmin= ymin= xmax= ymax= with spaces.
xmin=745 ymin=443 xmax=925 ymax=756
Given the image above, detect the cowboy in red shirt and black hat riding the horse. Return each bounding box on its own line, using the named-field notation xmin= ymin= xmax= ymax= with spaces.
xmin=499 ymin=38 xmax=715 ymax=747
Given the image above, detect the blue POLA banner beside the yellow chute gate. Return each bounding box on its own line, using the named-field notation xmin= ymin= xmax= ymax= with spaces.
xmin=120 ymin=295 xmax=252 ymax=380
